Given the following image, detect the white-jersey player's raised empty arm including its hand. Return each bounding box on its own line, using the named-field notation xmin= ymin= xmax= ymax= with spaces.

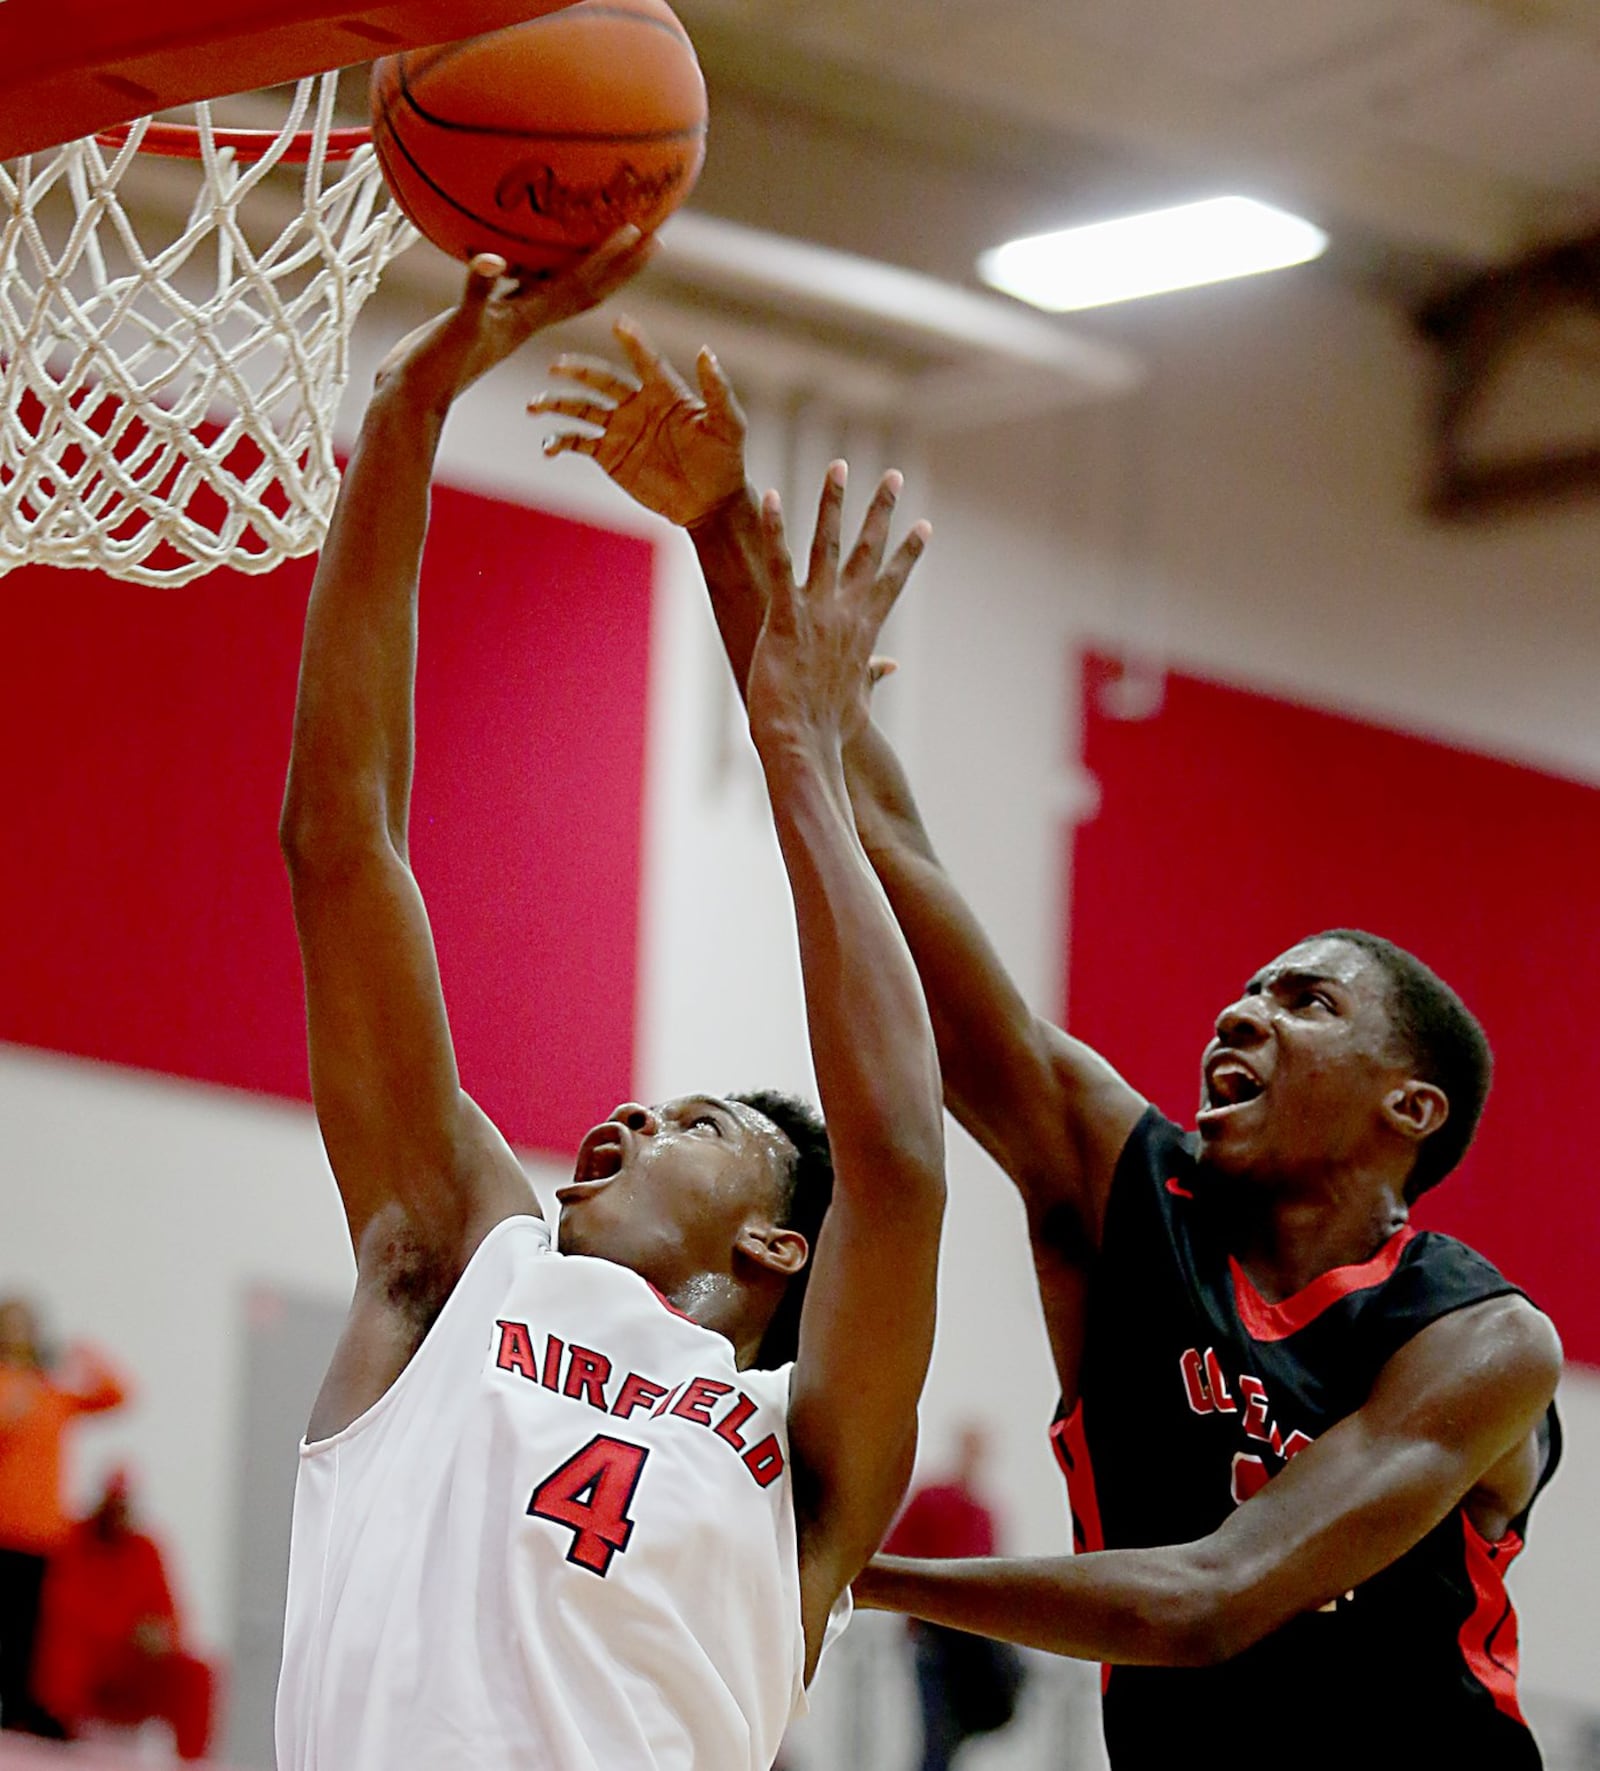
xmin=750 ymin=462 xmax=944 ymax=1661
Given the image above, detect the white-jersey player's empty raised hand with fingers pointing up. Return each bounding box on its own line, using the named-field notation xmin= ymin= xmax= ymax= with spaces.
xmin=748 ymin=460 xmax=932 ymax=751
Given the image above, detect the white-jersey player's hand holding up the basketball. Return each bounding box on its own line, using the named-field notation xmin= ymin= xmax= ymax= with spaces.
xmin=377 ymin=227 xmax=656 ymax=411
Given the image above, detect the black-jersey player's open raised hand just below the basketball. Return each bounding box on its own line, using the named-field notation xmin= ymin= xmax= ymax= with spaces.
xmin=528 ymin=321 xmax=744 ymax=530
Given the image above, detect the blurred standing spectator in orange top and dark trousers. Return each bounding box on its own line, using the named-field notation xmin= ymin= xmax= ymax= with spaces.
xmin=0 ymin=1298 xmax=126 ymax=1737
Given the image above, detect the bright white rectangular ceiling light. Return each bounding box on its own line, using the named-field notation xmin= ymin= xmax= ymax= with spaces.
xmin=978 ymin=197 xmax=1327 ymax=313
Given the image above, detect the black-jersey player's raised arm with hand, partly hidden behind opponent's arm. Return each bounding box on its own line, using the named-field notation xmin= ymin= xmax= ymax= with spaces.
xmin=532 ymin=322 xmax=1145 ymax=1390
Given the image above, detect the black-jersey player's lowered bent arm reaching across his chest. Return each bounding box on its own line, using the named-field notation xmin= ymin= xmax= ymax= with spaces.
xmin=856 ymin=1298 xmax=1561 ymax=1667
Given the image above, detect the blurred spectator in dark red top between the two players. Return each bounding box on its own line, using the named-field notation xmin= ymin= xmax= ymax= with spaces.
xmin=884 ymin=1426 xmax=1022 ymax=1771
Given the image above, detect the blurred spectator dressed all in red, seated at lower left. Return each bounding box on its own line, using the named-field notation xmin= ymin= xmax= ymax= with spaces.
xmin=34 ymin=1470 xmax=213 ymax=1759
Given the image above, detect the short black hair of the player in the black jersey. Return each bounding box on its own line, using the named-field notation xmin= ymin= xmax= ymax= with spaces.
xmin=1313 ymin=928 xmax=1494 ymax=1201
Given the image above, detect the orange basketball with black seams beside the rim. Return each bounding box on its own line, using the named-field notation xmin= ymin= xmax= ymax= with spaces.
xmin=372 ymin=0 xmax=705 ymax=275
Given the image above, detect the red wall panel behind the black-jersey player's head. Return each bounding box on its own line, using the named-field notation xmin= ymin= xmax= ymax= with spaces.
xmin=1070 ymin=655 xmax=1600 ymax=1364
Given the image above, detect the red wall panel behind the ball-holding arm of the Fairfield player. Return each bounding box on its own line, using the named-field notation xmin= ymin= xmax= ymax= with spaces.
xmin=0 ymin=487 xmax=652 ymax=1151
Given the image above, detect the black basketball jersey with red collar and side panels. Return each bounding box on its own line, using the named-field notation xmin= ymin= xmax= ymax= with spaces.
xmin=1052 ymin=1109 xmax=1559 ymax=1771
